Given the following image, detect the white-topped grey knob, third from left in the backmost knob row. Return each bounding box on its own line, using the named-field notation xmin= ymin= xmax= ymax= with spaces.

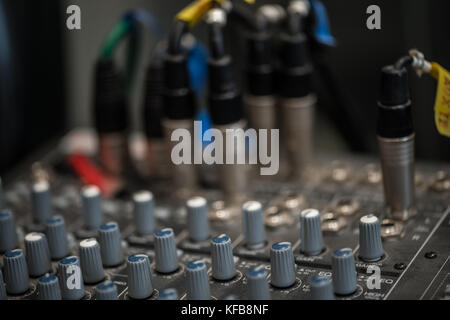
xmin=133 ymin=191 xmax=155 ymax=236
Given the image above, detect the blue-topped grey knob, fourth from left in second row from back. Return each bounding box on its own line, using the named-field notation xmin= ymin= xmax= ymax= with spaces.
xmin=155 ymin=228 xmax=178 ymax=273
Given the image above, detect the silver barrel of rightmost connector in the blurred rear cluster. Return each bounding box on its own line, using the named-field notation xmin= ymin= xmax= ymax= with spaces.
xmin=279 ymin=94 xmax=317 ymax=177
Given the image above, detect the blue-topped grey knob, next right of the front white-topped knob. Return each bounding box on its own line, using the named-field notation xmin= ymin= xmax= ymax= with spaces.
xmin=127 ymin=254 xmax=153 ymax=299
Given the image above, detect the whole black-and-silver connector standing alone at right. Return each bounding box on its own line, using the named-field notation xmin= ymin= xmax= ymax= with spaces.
xmin=377 ymin=66 xmax=415 ymax=221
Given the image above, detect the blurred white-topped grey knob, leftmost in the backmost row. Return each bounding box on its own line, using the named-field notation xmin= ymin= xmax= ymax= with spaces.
xmin=31 ymin=180 xmax=53 ymax=223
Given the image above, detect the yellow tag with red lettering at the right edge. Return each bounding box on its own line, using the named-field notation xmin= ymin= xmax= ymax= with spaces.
xmin=431 ymin=62 xmax=450 ymax=137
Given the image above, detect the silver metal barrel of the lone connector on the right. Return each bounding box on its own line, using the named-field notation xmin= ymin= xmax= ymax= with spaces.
xmin=378 ymin=134 xmax=415 ymax=221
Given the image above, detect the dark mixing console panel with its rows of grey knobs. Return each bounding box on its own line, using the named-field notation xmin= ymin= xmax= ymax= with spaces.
xmin=0 ymin=135 xmax=450 ymax=299
